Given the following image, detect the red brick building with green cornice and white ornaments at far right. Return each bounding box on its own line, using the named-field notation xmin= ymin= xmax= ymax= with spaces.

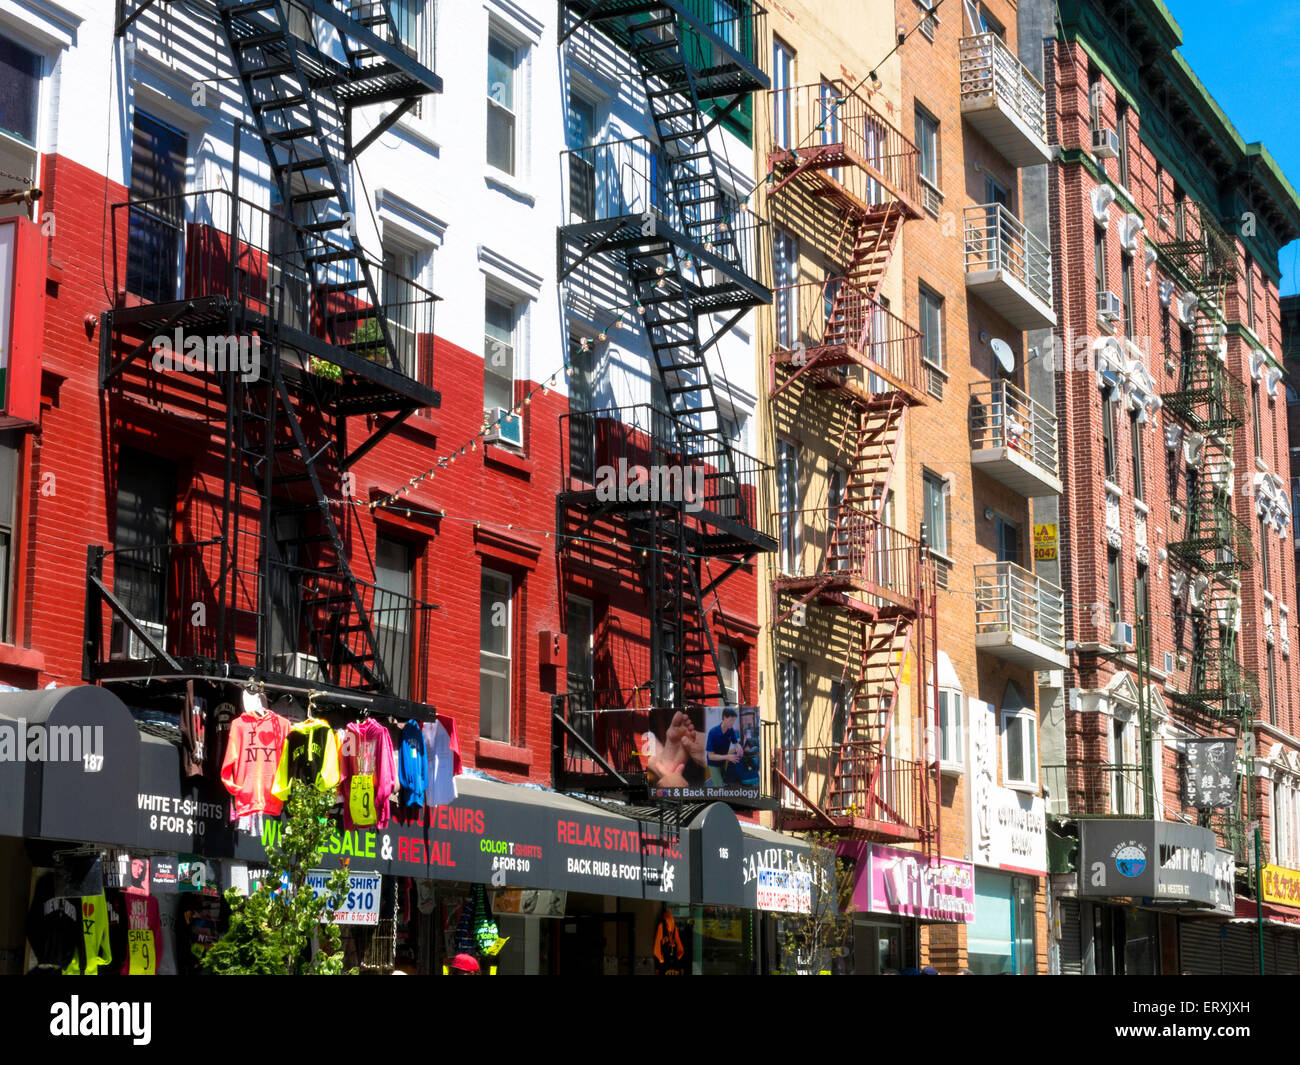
xmin=1043 ymin=0 xmax=1300 ymax=973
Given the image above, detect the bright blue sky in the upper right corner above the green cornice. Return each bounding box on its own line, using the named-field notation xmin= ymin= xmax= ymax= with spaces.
xmin=1165 ymin=0 xmax=1300 ymax=295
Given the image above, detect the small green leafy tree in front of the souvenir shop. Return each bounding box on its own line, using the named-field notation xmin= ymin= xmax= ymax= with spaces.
xmin=195 ymin=782 xmax=348 ymax=977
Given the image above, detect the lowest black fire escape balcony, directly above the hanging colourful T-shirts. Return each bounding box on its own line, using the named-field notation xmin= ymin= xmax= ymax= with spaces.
xmin=85 ymin=534 xmax=437 ymax=702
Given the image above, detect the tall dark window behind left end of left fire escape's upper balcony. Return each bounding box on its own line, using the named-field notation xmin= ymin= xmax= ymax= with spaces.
xmin=126 ymin=111 xmax=187 ymax=303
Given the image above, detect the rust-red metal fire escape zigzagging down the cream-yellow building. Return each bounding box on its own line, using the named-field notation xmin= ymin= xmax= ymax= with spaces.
xmin=767 ymin=82 xmax=939 ymax=853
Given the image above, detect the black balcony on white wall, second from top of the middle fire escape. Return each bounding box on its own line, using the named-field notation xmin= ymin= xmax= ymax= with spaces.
xmin=559 ymin=137 xmax=771 ymax=313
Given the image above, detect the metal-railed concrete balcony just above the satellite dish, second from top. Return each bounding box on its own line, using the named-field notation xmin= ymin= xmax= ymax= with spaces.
xmin=965 ymin=203 xmax=1056 ymax=330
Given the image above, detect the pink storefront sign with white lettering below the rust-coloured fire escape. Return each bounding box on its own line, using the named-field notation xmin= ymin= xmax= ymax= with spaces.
xmin=850 ymin=843 xmax=975 ymax=922
